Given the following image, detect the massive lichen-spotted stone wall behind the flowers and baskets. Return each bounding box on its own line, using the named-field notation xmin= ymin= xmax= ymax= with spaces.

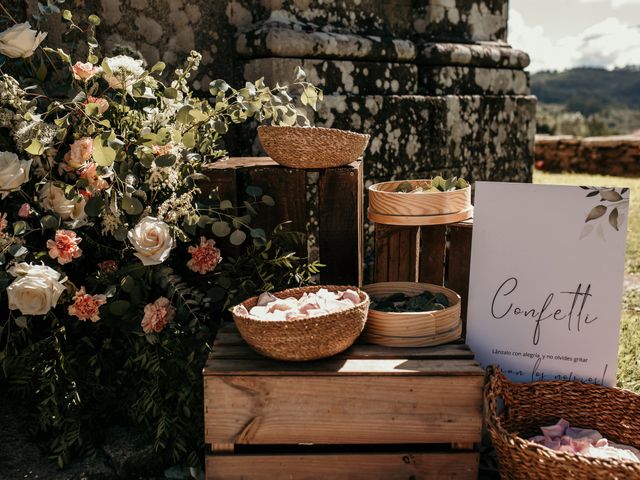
xmin=15 ymin=0 xmax=535 ymax=183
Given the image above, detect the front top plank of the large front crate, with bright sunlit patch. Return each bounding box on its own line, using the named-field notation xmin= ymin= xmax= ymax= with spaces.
xmin=203 ymin=357 xmax=484 ymax=376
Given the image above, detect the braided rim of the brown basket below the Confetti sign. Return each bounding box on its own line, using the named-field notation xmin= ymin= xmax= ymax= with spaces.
xmin=484 ymin=365 xmax=640 ymax=469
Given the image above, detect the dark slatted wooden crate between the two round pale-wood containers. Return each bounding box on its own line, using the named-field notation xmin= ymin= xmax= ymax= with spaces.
xmin=374 ymin=220 xmax=473 ymax=338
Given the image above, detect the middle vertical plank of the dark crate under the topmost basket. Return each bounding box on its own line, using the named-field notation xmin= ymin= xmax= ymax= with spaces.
xmin=243 ymin=164 xmax=307 ymax=237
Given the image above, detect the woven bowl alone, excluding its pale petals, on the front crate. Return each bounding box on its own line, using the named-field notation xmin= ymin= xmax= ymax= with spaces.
xmin=231 ymin=285 xmax=369 ymax=361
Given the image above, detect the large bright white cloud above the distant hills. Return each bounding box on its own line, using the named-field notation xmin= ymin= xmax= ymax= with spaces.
xmin=509 ymin=8 xmax=640 ymax=72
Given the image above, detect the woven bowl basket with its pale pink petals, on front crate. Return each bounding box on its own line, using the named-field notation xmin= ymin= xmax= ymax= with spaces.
xmin=231 ymin=285 xmax=369 ymax=361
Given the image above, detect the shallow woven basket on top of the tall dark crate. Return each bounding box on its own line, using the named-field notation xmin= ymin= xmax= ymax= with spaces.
xmin=258 ymin=125 xmax=369 ymax=168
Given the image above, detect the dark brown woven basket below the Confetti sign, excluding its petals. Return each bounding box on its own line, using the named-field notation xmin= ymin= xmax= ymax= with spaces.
xmin=485 ymin=367 xmax=640 ymax=480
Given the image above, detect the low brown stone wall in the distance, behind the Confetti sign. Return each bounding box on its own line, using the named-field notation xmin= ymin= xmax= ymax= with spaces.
xmin=535 ymin=135 xmax=640 ymax=177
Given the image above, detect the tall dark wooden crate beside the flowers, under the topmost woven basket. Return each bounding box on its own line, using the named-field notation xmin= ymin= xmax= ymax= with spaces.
xmin=200 ymin=157 xmax=364 ymax=286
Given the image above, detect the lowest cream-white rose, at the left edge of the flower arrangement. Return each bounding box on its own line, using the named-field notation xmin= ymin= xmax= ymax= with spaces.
xmin=7 ymin=263 xmax=65 ymax=315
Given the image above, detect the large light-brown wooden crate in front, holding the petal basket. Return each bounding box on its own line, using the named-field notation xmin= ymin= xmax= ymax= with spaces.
xmin=204 ymin=324 xmax=484 ymax=480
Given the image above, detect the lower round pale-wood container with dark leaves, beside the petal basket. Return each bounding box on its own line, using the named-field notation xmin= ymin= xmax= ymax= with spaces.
xmin=362 ymin=282 xmax=462 ymax=347
